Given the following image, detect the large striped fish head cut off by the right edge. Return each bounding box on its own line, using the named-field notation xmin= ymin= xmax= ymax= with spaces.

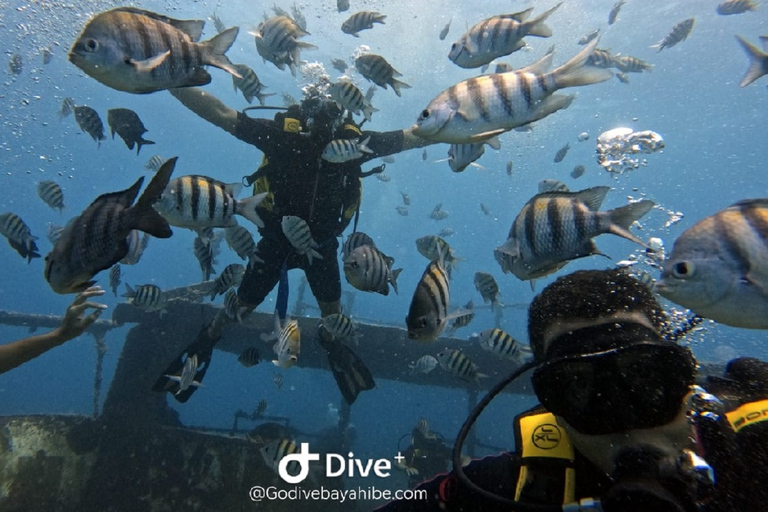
xmin=655 ymin=198 xmax=768 ymax=329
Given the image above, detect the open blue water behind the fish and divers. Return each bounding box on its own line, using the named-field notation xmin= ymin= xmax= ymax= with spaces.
xmin=0 ymin=0 xmax=768 ymax=496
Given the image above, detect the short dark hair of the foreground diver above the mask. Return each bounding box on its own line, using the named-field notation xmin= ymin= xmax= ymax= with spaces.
xmin=528 ymin=269 xmax=666 ymax=361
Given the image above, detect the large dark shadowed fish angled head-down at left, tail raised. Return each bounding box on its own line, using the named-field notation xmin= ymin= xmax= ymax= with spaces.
xmin=45 ymin=158 xmax=176 ymax=293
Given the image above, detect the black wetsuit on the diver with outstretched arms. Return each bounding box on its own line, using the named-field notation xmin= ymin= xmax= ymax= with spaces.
xmin=235 ymin=113 xmax=403 ymax=307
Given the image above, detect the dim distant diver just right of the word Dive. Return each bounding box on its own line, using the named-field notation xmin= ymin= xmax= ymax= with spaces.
xmin=396 ymin=418 xmax=451 ymax=487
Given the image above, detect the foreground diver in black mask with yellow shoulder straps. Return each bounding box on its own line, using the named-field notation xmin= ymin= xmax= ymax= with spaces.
xmin=380 ymin=270 xmax=768 ymax=512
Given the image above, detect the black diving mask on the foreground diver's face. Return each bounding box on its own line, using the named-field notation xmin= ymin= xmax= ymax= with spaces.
xmin=531 ymin=327 xmax=696 ymax=435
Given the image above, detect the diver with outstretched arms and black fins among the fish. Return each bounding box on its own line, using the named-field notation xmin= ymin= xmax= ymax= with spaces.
xmin=153 ymin=81 xmax=431 ymax=404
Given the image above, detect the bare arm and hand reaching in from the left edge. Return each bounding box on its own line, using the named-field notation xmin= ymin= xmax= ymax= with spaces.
xmin=0 ymin=286 xmax=107 ymax=373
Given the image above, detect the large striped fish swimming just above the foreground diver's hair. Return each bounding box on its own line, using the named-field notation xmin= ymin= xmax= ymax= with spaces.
xmin=494 ymin=187 xmax=653 ymax=280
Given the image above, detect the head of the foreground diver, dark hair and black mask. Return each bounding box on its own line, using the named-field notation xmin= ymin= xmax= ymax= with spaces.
xmin=528 ymin=270 xmax=696 ymax=436
